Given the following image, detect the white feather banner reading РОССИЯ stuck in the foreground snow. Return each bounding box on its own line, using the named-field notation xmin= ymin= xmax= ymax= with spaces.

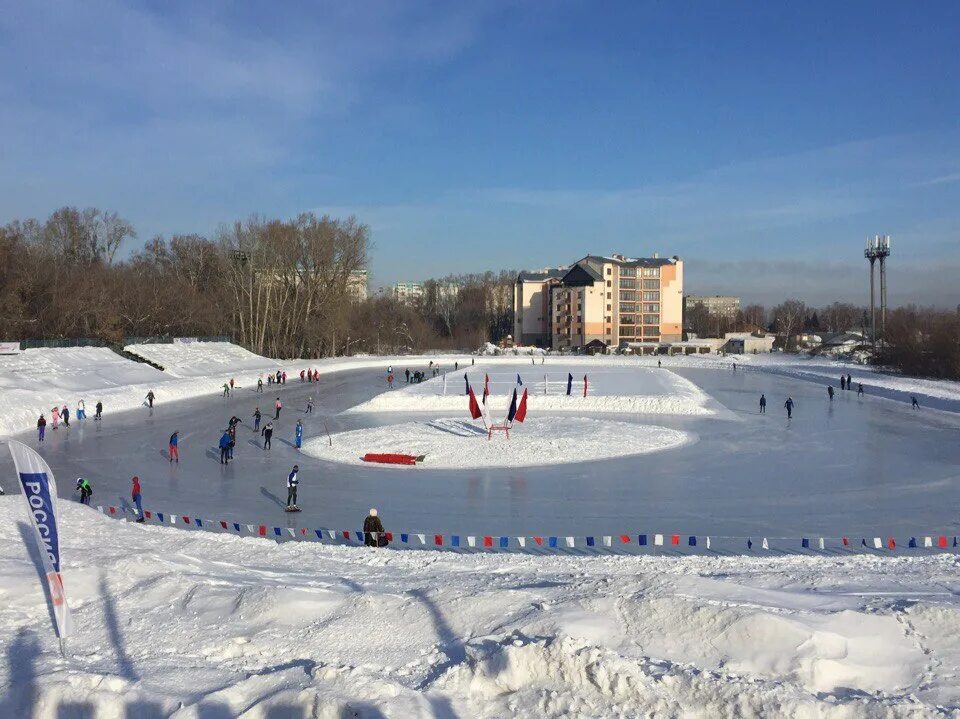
xmin=8 ymin=439 xmax=73 ymax=639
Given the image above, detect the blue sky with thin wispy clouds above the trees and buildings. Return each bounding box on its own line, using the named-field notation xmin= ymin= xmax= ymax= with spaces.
xmin=0 ymin=0 xmax=960 ymax=306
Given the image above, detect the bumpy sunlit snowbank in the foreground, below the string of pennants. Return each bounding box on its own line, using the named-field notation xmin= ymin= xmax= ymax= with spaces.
xmin=0 ymin=497 xmax=960 ymax=719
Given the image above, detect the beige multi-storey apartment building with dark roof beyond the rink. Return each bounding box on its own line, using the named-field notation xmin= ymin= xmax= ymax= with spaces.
xmin=514 ymin=255 xmax=683 ymax=349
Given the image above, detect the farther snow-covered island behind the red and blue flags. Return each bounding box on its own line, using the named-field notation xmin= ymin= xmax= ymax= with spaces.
xmin=347 ymin=362 xmax=716 ymax=418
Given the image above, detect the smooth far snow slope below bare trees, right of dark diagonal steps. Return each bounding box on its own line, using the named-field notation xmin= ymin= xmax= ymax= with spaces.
xmin=124 ymin=342 xmax=278 ymax=377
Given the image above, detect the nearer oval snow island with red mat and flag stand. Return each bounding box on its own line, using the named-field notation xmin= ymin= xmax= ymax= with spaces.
xmin=303 ymin=417 xmax=696 ymax=469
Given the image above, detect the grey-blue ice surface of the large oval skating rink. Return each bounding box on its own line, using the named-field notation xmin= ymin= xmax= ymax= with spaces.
xmin=0 ymin=360 xmax=960 ymax=537
